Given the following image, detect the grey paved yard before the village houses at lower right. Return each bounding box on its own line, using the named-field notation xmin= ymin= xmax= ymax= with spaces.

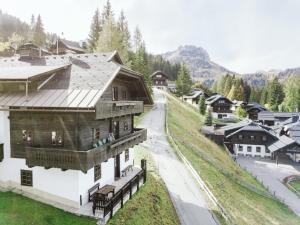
xmin=237 ymin=157 xmax=300 ymax=216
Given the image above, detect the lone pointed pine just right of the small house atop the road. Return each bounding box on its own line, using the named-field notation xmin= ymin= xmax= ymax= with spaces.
xmin=176 ymin=64 xmax=192 ymax=96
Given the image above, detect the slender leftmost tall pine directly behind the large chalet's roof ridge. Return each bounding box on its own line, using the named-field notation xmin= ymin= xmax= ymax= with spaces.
xmin=88 ymin=8 xmax=101 ymax=52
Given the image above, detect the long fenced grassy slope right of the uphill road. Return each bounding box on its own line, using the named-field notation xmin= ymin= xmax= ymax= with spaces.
xmin=167 ymin=92 xmax=300 ymax=225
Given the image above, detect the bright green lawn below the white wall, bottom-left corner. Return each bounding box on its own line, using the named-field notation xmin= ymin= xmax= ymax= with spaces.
xmin=0 ymin=192 xmax=96 ymax=225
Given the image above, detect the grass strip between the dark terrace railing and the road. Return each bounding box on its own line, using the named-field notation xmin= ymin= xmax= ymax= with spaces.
xmin=108 ymin=146 xmax=180 ymax=225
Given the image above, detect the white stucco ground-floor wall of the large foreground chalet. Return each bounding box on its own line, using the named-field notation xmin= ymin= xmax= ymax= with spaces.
xmin=0 ymin=111 xmax=134 ymax=207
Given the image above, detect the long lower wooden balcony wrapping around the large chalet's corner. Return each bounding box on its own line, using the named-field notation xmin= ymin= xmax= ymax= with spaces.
xmin=25 ymin=129 xmax=147 ymax=173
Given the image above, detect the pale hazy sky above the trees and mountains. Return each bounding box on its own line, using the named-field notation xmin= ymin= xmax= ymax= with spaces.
xmin=0 ymin=0 xmax=300 ymax=73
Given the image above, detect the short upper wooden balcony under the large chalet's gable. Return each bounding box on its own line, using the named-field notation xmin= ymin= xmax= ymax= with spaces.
xmin=96 ymin=101 xmax=144 ymax=119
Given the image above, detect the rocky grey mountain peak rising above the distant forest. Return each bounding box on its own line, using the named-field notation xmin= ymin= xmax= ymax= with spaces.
xmin=162 ymin=45 xmax=232 ymax=86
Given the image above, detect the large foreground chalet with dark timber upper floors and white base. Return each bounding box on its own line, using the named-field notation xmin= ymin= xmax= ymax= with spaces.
xmin=0 ymin=46 xmax=153 ymax=213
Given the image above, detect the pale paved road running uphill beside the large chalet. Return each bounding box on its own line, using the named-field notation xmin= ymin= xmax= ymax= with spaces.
xmin=140 ymin=90 xmax=217 ymax=225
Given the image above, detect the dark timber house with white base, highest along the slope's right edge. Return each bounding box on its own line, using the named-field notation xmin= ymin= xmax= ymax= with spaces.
xmin=205 ymin=94 xmax=234 ymax=119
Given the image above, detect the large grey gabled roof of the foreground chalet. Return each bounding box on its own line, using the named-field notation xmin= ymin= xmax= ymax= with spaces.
xmin=0 ymin=52 xmax=153 ymax=109
